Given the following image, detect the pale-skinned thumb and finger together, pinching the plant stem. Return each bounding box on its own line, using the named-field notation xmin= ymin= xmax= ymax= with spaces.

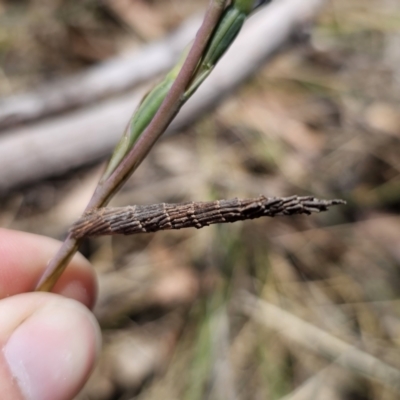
xmin=0 ymin=229 xmax=101 ymax=400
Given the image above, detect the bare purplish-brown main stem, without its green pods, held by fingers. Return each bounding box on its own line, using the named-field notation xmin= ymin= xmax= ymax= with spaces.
xmin=36 ymin=0 xmax=230 ymax=291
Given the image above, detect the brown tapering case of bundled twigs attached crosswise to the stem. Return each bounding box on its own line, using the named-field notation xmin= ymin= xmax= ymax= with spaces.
xmin=70 ymin=196 xmax=345 ymax=238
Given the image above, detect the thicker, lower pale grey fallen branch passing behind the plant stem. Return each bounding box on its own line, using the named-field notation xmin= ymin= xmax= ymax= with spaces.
xmin=0 ymin=0 xmax=326 ymax=193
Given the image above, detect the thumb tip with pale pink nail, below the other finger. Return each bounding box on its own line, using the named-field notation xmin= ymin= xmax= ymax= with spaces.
xmin=0 ymin=293 xmax=101 ymax=400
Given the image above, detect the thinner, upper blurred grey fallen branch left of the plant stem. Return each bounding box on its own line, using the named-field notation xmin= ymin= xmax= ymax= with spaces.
xmin=0 ymin=17 xmax=201 ymax=129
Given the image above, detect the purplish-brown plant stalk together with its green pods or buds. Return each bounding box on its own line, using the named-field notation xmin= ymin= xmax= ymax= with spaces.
xmin=36 ymin=0 xmax=306 ymax=291
